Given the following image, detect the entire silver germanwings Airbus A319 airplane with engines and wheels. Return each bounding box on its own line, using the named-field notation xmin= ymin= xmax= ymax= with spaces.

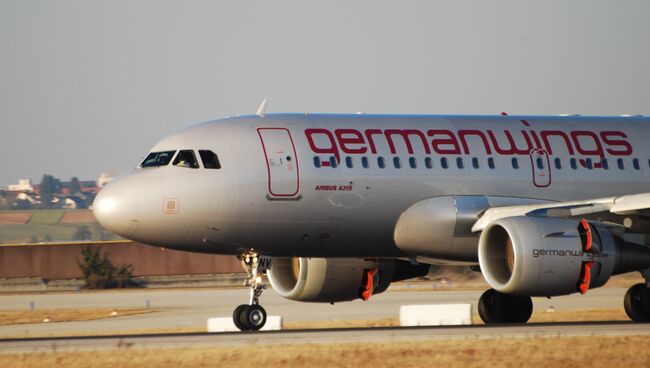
xmin=94 ymin=108 xmax=650 ymax=331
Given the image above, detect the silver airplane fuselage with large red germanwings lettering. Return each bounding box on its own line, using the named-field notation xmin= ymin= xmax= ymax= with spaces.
xmin=95 ymin=114 xmax=650 ymax=263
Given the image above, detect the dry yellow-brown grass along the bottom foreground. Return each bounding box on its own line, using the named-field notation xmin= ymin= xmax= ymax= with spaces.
xmin=0 ymin=336 xmax=650 ymax=368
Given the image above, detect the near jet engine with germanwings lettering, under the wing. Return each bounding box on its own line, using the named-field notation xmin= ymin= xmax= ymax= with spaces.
xmin=478 ymin=216 xmax=650 ymax=296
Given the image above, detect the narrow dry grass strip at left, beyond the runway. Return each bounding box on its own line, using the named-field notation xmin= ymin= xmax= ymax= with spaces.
xmin=0 ymin=309 xmax=154 ymax=326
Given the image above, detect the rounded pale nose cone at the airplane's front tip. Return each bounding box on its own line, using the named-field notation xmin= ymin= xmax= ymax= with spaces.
xmin=93 ymin=178 xmax=140 ymax=238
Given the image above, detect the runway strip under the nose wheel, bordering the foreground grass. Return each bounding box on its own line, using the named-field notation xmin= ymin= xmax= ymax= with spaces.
xmin=0 ymin=322 xmax=650 ymax=354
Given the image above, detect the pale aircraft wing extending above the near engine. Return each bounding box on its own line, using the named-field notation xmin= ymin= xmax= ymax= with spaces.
xmin=472 ymin=193 xmax=650 ymax=232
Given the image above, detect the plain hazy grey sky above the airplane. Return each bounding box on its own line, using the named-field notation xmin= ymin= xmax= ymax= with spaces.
xmin=0 ymin=0 xmax=650 ymax=187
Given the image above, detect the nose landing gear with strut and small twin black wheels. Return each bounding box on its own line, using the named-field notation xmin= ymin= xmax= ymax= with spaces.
xmin=232 ymin=253 xmax=268 ymax=331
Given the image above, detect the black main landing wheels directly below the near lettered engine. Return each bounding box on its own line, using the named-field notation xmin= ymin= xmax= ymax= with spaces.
xmin=478 ymin=289 xmax=533 ymax=324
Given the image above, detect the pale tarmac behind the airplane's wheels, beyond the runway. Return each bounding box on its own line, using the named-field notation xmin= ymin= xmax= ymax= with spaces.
xmin=0 ymin=287 xmax=632 ymax=345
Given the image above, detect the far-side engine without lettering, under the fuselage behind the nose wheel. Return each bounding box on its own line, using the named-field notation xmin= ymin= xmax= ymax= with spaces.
xmin=268 ymin=258 xmax=429 ymax=303
